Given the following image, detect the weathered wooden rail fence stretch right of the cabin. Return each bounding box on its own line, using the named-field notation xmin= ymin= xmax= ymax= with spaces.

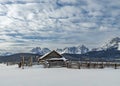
xmin=66 ymin=61 xmax=120 ymax=69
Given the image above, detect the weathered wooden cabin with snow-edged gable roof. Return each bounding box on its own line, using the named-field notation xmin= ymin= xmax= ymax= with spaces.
xmin=39 ymin=50 xmax=66 ymax=67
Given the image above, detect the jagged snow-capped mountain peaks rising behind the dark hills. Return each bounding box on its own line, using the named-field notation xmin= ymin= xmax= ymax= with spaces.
xmin=31 ymin=37 xmax=120 ymax=55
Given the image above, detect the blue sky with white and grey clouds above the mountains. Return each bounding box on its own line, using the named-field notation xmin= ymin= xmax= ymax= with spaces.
xmin=0 ymin=0 xmax=120 ymax=52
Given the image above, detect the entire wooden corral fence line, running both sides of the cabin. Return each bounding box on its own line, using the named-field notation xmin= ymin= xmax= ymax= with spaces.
xmin=7 ymin=57 xmax=120 ymax=69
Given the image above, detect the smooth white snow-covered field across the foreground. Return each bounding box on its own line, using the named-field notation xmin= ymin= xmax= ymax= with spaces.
xmin=0 ymin=64 xmax=120 ymax=86
